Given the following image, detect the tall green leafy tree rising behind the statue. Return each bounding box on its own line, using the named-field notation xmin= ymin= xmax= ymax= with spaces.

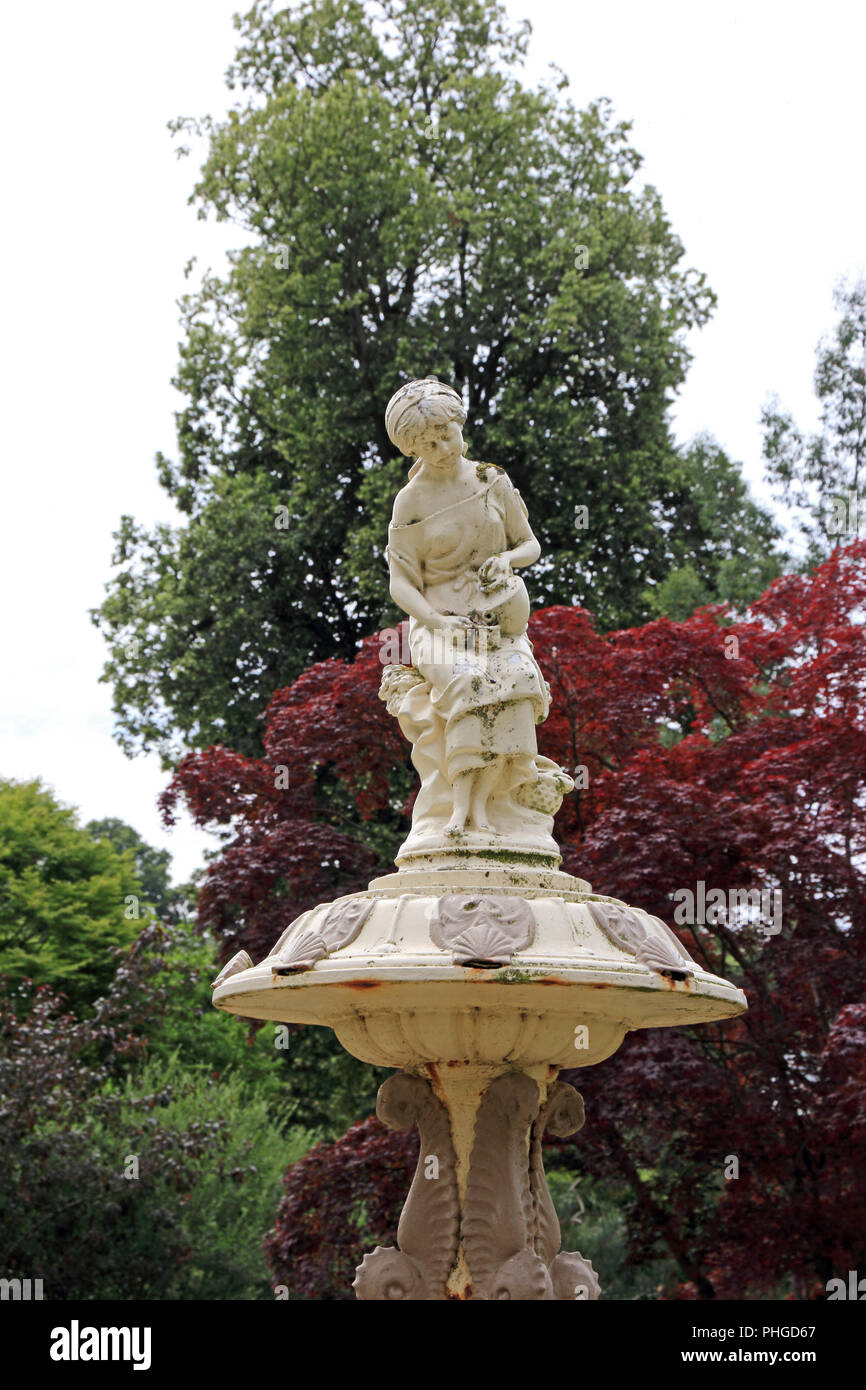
xmin=95 ymin=0 xmax=783 ymax=765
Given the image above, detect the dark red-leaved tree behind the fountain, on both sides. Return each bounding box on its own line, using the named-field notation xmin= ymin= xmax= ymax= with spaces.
xmin=165 ymin=541 xmax=866 ymax=1298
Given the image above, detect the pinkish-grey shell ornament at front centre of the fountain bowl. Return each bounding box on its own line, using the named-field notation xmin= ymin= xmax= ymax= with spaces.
xmin=430 ymin=894 xmax=535 ymax=970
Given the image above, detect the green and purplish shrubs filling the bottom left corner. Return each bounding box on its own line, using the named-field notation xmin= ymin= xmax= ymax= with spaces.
xmin=0 ymin=956 xmax=310 ymax=1300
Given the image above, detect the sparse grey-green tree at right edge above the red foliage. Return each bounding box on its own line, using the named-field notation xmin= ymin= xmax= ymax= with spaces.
xmin=762 ymin=279 xmax=866 ymax=564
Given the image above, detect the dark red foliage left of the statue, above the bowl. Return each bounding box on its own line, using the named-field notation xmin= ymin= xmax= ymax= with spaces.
xmin=160 ymin=638 xmax=397 ymax=959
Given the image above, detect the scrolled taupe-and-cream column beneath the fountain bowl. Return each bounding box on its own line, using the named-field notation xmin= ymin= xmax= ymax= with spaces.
xmin=354 ymin=1063 xmax=601 ymax=1301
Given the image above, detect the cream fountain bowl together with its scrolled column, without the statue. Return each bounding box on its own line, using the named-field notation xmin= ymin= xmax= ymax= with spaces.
xmin=214 ymin=866 xmax=745 ymax=1300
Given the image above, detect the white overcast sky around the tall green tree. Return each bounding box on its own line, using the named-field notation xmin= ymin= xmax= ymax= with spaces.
xmin=0 ymin=0 xmax=866 ymax=878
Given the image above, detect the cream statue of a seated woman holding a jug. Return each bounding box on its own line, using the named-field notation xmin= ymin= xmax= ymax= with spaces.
xmin=379 ymin=377 xmax=574 ymax=863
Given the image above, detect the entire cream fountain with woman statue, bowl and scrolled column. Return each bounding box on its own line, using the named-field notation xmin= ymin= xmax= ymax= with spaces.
xmin=214 ymin=378 xmax=746 ymax=1300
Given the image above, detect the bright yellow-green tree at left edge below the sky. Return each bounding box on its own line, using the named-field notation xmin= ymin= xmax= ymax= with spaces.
xmin=0 ymin=780 xmax=145 ymax=1008
